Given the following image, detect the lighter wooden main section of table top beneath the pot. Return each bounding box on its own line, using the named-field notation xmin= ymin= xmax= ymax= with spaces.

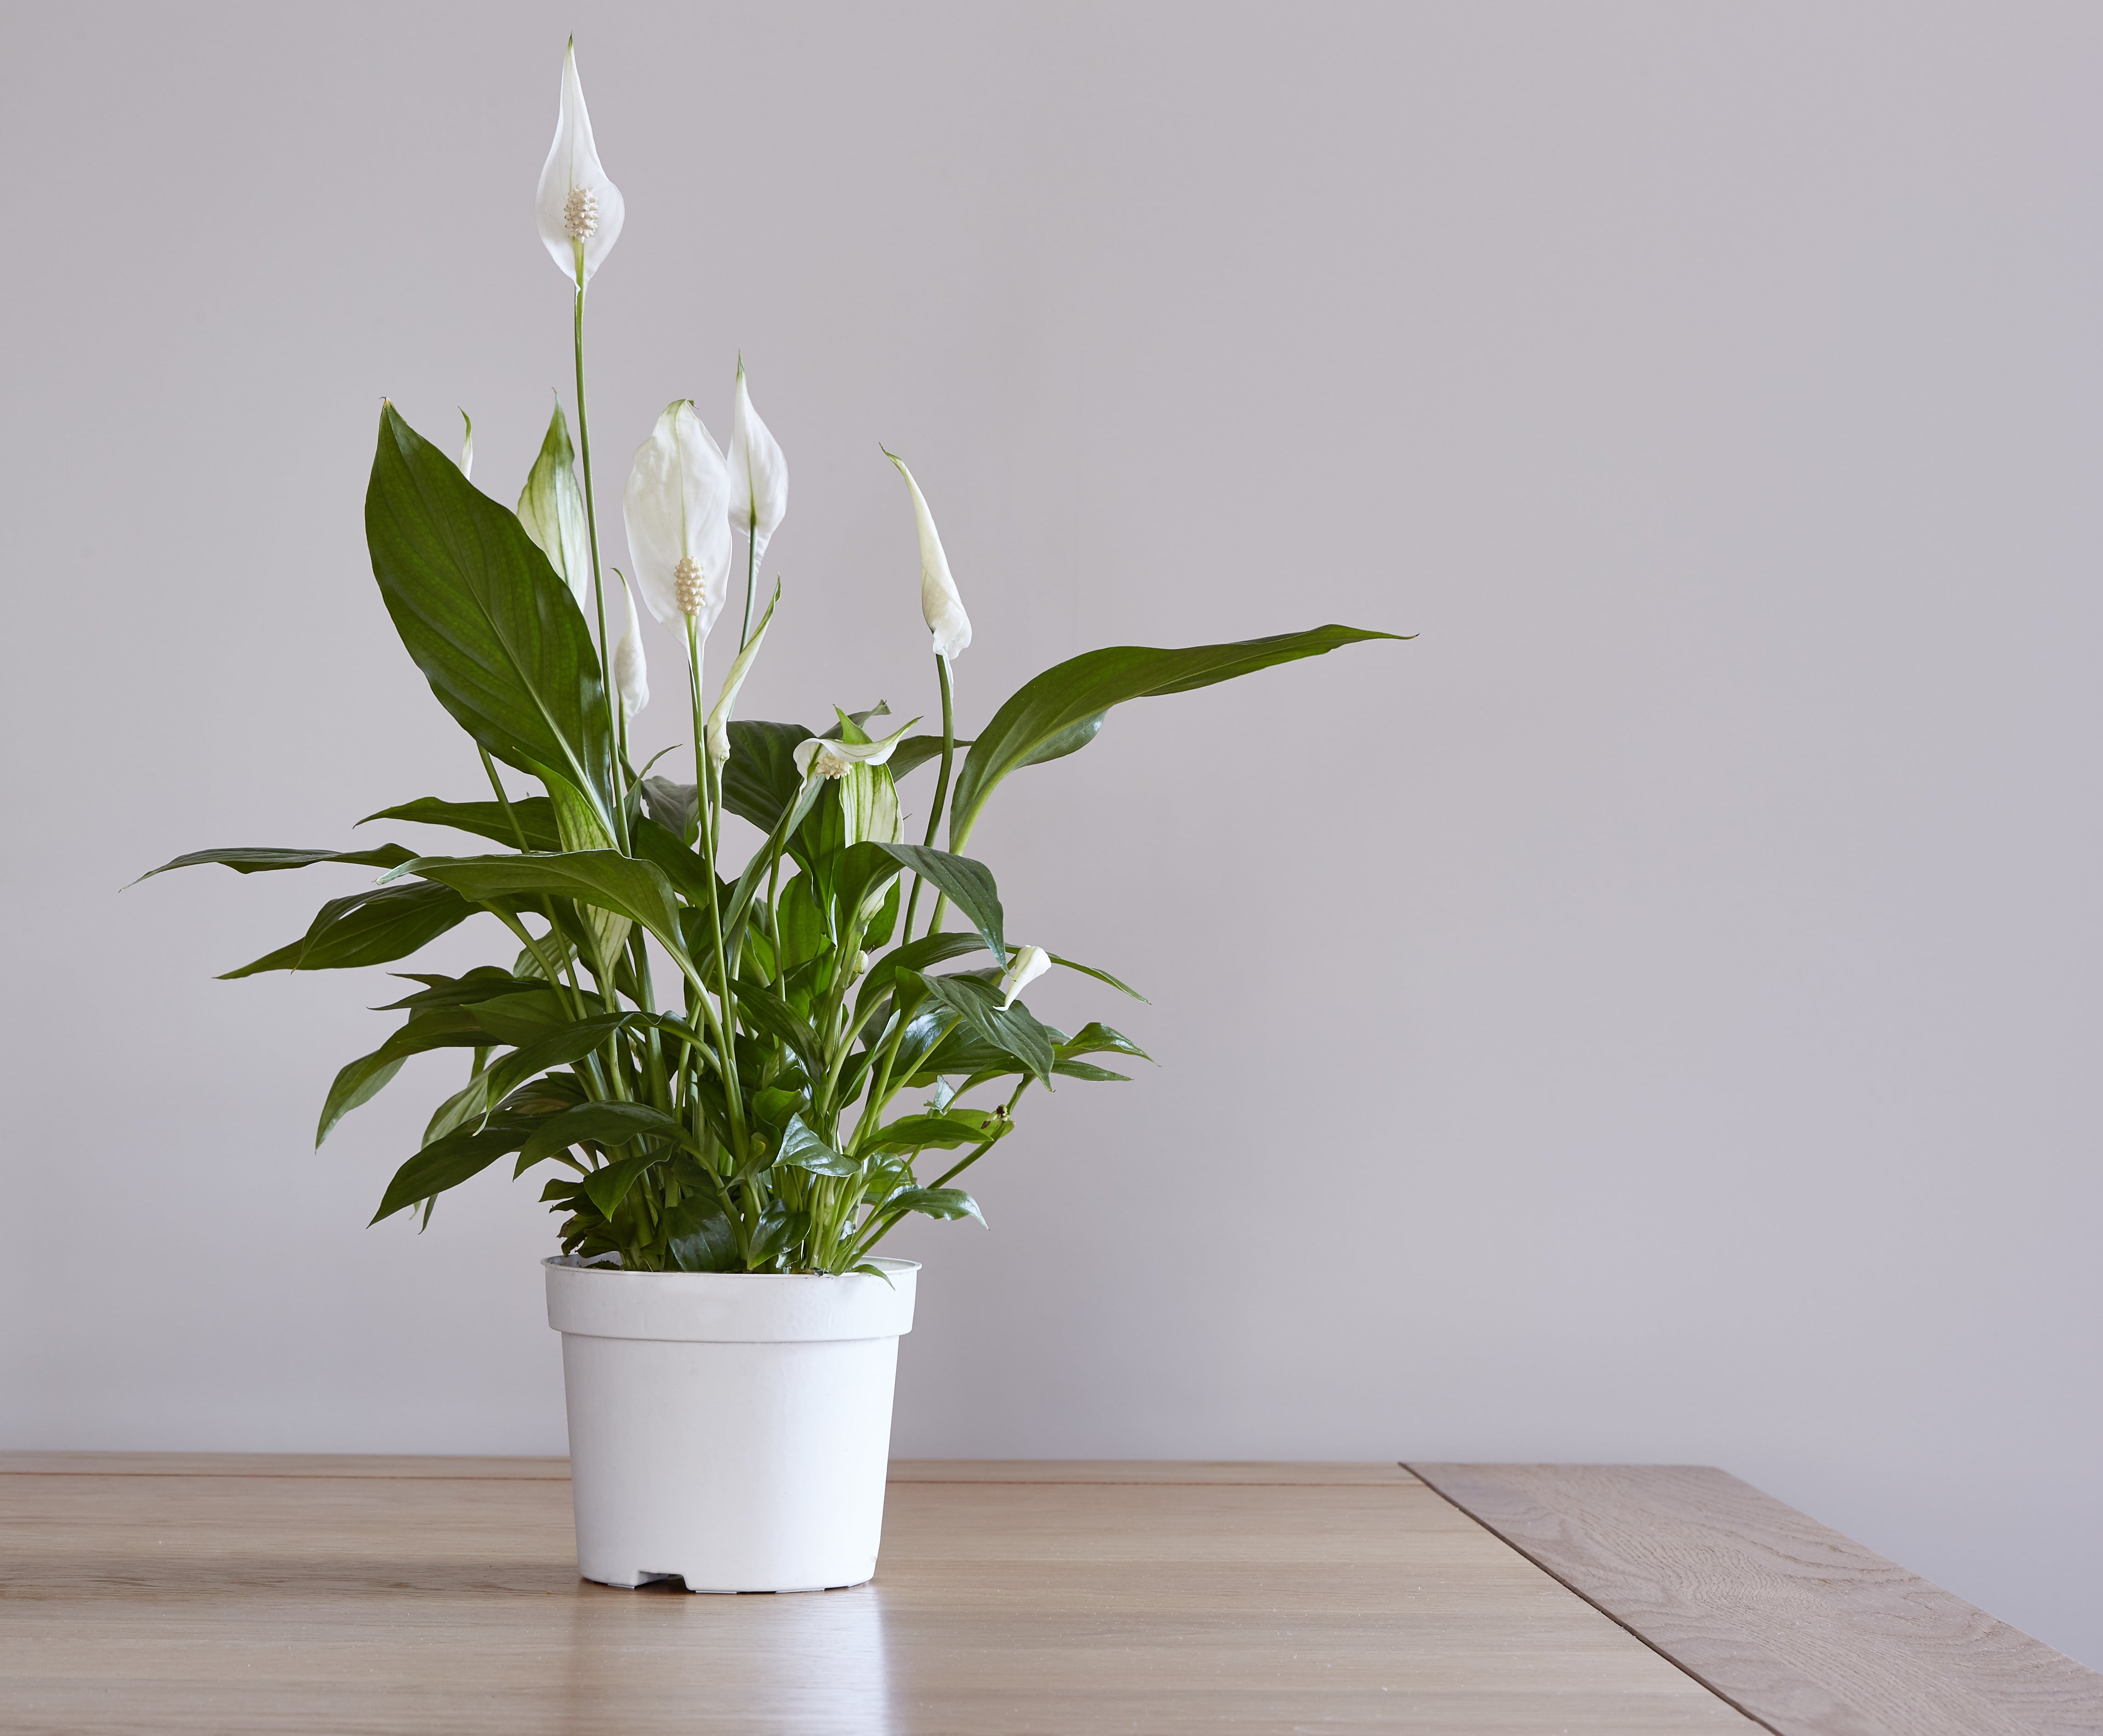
xmin=0 ymin=1456 xmax=1754 ymax=1736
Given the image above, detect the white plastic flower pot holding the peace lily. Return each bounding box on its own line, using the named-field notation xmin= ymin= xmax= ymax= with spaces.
xmin=543 ymin=1258 xmax=919 ymax=1591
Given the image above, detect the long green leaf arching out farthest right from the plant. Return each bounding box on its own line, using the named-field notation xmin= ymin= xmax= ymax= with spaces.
xmin=948 ymin=627 xmax=1407 ymax=850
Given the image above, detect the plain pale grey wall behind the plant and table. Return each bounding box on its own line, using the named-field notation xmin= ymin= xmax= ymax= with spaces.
xmin=0 ymin=0 xmax=2103 ymax=1664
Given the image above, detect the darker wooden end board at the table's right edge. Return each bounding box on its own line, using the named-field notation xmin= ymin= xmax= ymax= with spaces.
xmin=1411 ymin=1462 xmax=2103 ymax=1736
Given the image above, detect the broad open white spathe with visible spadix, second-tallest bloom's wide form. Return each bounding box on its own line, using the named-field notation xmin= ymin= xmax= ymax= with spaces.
xmin=620 ymin=398 xmax=730 ymax=637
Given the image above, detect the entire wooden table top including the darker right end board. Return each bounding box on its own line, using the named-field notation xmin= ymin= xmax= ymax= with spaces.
xmin=0 ymin=1454 xmax=2103 ymax=1736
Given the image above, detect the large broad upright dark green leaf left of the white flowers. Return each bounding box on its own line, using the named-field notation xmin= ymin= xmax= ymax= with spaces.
xmin=366 ymin=404 xmax=612 ymax=819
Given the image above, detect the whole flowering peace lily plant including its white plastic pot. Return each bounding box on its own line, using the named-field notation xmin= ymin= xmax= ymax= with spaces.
xmin=154 ymin=48 xmax=1394 ymax=1591
